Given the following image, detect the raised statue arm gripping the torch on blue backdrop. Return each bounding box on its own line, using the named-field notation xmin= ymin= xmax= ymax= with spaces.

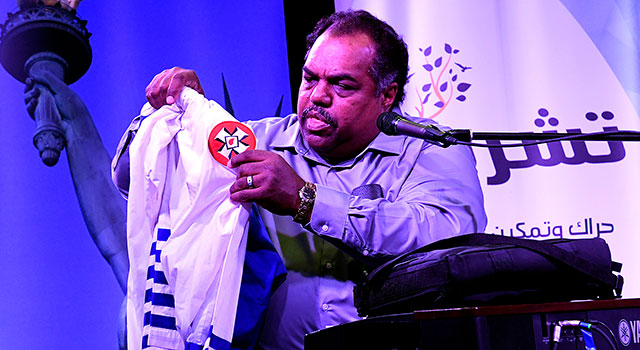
xmin=25 ymin=72 xmax=129 ymax=291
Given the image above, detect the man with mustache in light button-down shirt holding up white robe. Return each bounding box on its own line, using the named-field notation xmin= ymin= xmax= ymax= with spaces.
xmin=125 ymin=11 xmax=486 ymax=349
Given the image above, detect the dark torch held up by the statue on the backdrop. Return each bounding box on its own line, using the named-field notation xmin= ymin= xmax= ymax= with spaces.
xmin=0 ymin=0 xmax=92 ymax=166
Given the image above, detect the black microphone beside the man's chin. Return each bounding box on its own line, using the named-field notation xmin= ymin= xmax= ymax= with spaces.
xmin=377 ymin=112 xmax=458 ymax=147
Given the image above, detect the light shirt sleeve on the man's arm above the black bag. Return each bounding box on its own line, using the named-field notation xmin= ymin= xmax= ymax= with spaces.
xmin=308 ymin=146 xmax=487 ymax=261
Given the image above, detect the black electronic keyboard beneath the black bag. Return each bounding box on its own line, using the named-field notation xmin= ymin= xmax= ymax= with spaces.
xmin=304 ymin=299 xmax=640 ymax=350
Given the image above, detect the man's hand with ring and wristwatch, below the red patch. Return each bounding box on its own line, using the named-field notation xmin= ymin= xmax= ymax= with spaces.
xmin=229 ymin=150 xmax=305 ymax=216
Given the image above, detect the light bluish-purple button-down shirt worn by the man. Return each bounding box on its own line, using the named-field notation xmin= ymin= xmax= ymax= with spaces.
xmin=114 ymin=110 xmax=487 ymax=349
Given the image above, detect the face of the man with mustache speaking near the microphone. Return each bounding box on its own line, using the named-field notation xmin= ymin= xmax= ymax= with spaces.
xmin=298 ymin=31 xmax=397 ymax=162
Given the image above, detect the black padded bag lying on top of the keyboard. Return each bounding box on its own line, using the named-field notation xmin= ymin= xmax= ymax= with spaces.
xmin=354 ymin=234 xmax=623 ymax=316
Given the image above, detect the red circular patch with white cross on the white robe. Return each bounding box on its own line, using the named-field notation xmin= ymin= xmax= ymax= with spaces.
xmin=209 ymin=121 xmax=256 ymax=165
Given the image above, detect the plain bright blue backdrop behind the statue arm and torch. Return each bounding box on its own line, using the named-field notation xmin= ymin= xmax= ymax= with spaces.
xmin=0 ymin=0 xmax=292 ymax=350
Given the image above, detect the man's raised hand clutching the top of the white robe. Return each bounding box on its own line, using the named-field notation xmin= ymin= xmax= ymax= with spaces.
xmin=145 ymin=67 xmax=204 ymax=109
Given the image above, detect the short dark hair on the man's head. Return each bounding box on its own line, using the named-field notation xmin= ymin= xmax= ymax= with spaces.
xmin=307 ymin=10 xmax=409 ymax=107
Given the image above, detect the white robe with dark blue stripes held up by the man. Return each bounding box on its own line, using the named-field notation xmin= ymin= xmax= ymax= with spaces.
xmin=127 ymin=88 xmax=250 ymax=349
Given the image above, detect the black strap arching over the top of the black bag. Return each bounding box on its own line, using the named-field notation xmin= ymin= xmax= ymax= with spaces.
xmin=367 ymin=233 xmax=620 ymax=295
